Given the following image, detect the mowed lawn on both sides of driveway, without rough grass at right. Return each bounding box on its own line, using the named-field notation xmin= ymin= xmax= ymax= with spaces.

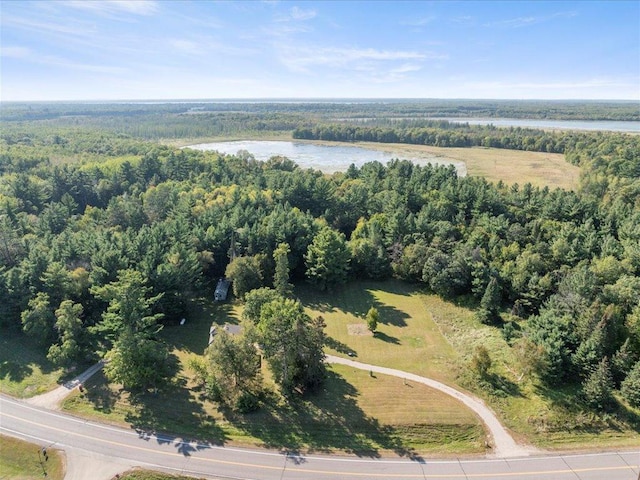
xmin=64 ymin=281 xmax=485 ymax=457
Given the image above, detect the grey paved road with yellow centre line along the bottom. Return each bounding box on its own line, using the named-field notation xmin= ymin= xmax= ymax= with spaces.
xmin=0 ymin=395 xmax=640 ymax=480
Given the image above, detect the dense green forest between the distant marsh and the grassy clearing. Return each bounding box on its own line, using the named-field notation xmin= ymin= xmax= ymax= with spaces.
xmin=0 ymin=104 xmax=640 ymax=410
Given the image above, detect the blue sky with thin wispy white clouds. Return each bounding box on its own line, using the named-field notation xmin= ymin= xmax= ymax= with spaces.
xmin=0 ymin=0 xmax=640 ymax=101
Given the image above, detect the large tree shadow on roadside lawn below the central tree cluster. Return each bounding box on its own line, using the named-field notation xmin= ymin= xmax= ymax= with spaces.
xmin=228 ymin=371 xmax=418 ymax=459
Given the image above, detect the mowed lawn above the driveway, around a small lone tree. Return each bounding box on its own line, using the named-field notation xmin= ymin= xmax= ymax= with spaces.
xmin=298 ymin=280 xmax=464 ymax=384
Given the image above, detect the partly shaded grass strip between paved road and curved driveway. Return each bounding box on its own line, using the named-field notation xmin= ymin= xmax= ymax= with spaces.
xmin=64 ymin=365 xmax=485 ymax=457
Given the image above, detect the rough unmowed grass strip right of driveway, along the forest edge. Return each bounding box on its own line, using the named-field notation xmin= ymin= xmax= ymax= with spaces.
xmin=421 ymin=295 xmax=640 ymax=450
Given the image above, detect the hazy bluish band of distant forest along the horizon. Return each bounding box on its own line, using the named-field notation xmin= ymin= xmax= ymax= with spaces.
xmin=1 ymin=99 xmax=640 ymax=121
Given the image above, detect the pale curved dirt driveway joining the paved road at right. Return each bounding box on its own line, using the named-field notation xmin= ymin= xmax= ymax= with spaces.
xmin=326 ymin=355 xmax=536 ymax=458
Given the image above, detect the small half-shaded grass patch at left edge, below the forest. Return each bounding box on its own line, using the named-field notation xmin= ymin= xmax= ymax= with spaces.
xmin=0 ymin=333 xmax=64 ymax=398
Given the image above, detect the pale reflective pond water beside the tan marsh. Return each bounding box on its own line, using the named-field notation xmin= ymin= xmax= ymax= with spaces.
xmin=186 ymin=140 xmax=466 ymax=176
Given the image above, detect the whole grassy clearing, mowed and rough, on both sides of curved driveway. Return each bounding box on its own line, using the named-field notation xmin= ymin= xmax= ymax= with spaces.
xmin=56 ymin=281 xmax=640 ymax=457
